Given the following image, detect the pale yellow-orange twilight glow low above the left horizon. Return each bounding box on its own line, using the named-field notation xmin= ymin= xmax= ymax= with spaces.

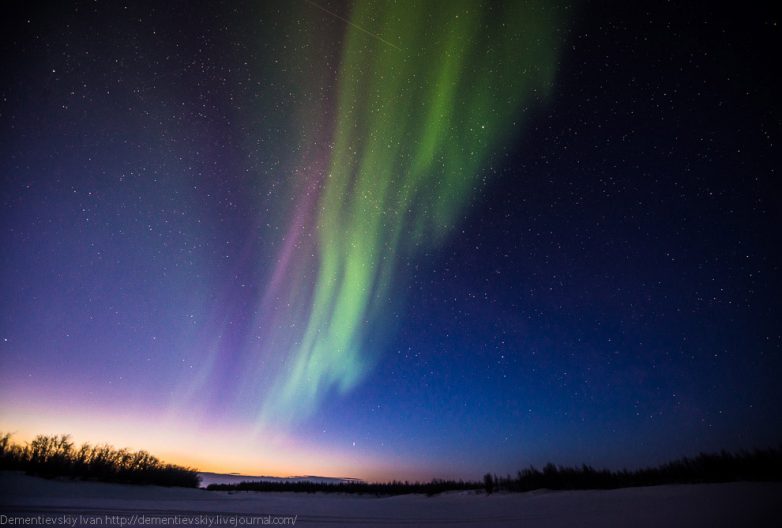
xmin=0 ymin=398 xmax=427 ymax=481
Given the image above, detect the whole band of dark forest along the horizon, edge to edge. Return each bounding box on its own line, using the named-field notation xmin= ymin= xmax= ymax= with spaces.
xmin=0 ymin=434 xmax=782 ymax=495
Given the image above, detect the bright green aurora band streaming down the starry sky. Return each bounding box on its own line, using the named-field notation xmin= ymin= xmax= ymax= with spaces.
xmin=260 ymin=1 xmax=563 ymax=425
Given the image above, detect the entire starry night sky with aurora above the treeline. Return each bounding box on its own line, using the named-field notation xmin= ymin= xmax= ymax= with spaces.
xmin=0 ymin=0 xmax=782 ymax=480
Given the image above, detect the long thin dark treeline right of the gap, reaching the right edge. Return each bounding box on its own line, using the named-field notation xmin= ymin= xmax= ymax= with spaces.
xmin=207 ymin=449 xmax=782 ymax=495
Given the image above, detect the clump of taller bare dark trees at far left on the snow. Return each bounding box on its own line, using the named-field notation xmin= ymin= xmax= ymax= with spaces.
xmin=0 ymin=434 xmax=200 ymax=488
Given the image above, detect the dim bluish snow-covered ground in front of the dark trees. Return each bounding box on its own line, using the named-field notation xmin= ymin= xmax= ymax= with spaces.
xmin=0 ymin=472 xmax=782 ymax=528
